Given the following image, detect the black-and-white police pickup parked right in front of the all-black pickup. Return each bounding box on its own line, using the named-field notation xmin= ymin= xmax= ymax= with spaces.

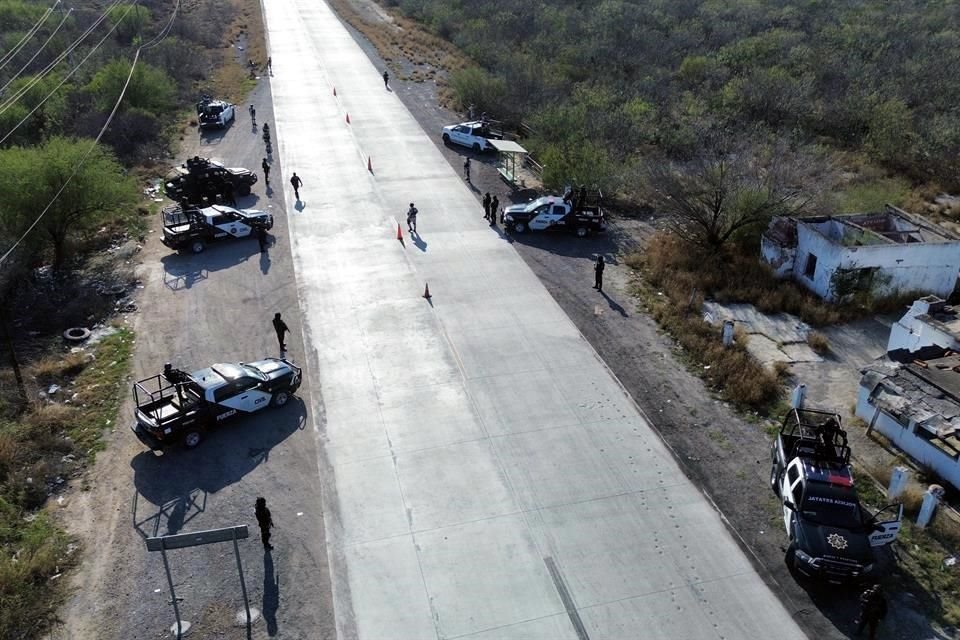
xmin=160 ymin=204 xmax=273 ymax=253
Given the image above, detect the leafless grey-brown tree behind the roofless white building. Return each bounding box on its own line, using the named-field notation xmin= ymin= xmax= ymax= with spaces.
xmin=645 ymin=136 xmax=834 ymax=251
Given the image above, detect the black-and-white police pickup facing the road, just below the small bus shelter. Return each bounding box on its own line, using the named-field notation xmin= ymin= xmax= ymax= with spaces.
xmin=503 ymin=190 xmax=607 ymax=238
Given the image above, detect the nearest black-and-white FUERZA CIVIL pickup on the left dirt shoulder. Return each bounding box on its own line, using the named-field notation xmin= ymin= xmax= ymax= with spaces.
xmin=131 ymin=358 xmax=303 ymax=451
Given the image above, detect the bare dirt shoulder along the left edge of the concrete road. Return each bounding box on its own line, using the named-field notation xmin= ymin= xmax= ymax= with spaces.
xmin=52 ymin=81 xmax=334 ymax=640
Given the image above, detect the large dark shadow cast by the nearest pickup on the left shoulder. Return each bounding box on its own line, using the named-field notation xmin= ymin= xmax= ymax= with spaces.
xmin=130 ymin=397 xmax=307 ymax=538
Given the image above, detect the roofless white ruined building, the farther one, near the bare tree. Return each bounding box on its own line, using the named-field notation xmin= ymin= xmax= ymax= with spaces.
xmin=761 ymin=205 xmax=960 ymax=300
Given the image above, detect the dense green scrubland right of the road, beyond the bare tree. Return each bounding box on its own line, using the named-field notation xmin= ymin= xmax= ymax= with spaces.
xmin=386 ymin=0 xmax=960 ymax=188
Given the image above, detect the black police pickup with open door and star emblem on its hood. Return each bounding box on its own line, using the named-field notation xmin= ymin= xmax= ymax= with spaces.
xmin=770 ymin=409 xmax=903 ymax=583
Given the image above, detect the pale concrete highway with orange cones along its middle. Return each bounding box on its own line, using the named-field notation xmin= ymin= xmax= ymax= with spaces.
xmin=265 ymin=0 xmax=802 ymax=638
